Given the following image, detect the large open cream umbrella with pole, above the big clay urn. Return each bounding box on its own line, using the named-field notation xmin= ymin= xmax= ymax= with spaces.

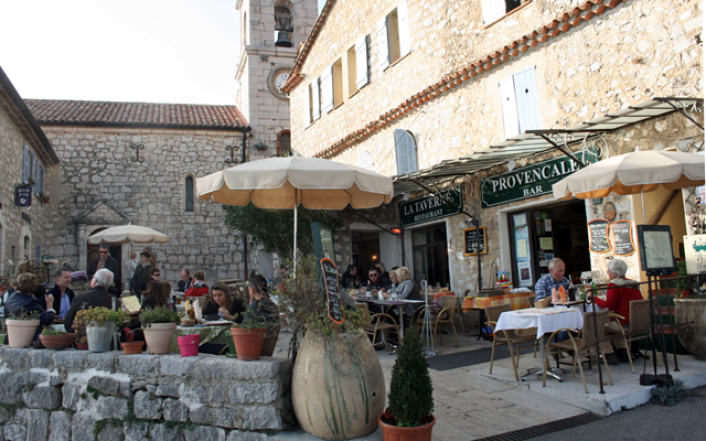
xmin=196 ymin=157 xmax=394 ymax=277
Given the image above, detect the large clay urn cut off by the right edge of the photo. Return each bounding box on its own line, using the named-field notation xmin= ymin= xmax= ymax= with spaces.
xmin=674 ymin=299 xmax=706 ymax=360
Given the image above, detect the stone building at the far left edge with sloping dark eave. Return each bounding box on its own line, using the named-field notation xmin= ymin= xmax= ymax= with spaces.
xmin=0 ymin=68 xmax=59 ymax=287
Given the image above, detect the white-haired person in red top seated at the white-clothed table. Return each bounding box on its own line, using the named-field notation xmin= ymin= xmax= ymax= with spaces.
xmin=586 ymin=259 xmax=643 ymax=363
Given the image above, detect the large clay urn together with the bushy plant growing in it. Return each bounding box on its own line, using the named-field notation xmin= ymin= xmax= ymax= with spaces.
xmin=284 ymin=257 xmax=385 ymax=440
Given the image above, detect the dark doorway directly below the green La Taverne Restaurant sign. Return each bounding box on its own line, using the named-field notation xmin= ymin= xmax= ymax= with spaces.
xmin=412 ymin=222 xmax=450 ymax=287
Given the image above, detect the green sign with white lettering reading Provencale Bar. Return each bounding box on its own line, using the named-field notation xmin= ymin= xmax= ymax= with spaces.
xmin=480 ymin=150 xmax=598 ymax=208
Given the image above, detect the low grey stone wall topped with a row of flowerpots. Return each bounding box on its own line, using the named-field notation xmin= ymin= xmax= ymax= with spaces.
xmin=0 ymin=347 xmax=292 ymax=441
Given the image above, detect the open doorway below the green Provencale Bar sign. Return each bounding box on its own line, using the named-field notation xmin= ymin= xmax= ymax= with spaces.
xmin=508 ymin=201 xmax=591 ymax=289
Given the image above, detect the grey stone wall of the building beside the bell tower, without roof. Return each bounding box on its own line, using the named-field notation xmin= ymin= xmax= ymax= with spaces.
xmin=43 ymin=125 xmax=244 ymax=285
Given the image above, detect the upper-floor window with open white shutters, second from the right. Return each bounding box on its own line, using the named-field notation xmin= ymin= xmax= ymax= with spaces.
xmin=375 ymin=2 xmax=410 ymax=70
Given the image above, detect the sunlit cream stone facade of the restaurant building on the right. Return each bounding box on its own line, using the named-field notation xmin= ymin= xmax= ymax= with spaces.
xmin=286 ymin=0 xmax=703 ymax=292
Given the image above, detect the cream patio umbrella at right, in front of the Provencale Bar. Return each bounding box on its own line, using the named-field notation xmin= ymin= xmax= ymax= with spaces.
xmin=552 ymin=151 xmax=705 ymax=222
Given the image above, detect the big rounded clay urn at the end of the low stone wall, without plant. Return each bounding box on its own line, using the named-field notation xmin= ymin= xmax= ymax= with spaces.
xmin=292 ymin=333 xmax=385 ymax=440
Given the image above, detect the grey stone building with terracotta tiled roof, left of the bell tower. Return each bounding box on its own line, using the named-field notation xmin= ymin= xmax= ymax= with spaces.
xmin=25 ymin=100 xmax=250 ymax=286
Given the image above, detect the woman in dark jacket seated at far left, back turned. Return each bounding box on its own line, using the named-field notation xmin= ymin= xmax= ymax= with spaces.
xmin=5 ymin=273 xmax=56 ymax=347
